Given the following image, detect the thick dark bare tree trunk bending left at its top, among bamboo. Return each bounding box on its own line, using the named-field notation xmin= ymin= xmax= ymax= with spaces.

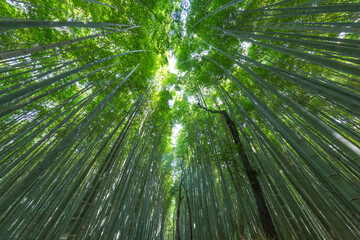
xmin=198 ymin=103 xmax=279 ymax=239
